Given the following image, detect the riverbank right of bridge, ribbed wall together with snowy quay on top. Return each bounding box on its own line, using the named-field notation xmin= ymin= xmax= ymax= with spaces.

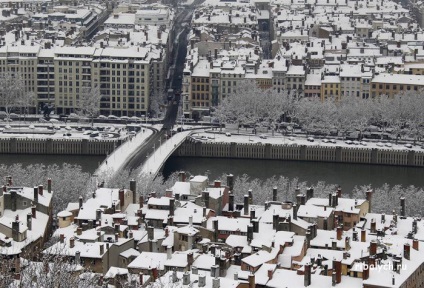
xmin=173 ymin=133 xmax=424 ymax=167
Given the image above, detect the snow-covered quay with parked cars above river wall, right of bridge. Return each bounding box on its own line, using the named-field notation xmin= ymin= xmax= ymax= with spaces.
xmin=191 ymin=130 xmax=424 ymax=152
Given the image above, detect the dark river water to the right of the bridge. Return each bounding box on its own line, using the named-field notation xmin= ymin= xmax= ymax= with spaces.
xmin=163 ymin=157 xmax=424 ymax=191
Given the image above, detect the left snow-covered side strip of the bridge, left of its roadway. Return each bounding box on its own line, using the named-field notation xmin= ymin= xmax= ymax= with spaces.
xmin=94 ymin=128 xmax=153 ymax=175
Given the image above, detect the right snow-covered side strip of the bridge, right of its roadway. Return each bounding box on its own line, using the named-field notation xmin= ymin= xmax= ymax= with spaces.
xmin=141 ymin=131 xmax=193 ymax=175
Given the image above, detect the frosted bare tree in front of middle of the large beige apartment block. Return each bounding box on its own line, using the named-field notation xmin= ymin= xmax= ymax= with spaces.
xmin=76 ymin=86 xmax=102 ymax=126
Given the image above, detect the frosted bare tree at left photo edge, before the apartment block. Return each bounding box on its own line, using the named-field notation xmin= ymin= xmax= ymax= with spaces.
xmin=0 ymin=72 xmax=24 ymax=121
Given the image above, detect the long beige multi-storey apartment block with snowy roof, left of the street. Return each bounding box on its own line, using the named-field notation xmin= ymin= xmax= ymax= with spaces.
xmin=0 ymin=45 xmax=154 ymax=116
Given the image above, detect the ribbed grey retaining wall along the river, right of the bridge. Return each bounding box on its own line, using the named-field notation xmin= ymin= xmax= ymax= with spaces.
xmin=173 ymin=139 xmax=424 ymax=167
